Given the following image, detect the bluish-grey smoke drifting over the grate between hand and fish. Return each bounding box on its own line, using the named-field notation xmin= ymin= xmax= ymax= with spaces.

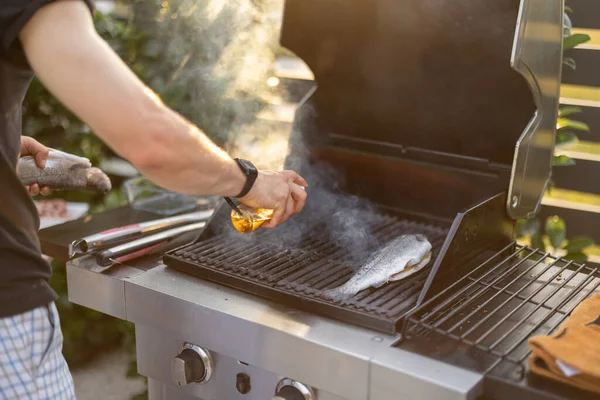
xmin=220 ymin=101 xmax=386 ymax=267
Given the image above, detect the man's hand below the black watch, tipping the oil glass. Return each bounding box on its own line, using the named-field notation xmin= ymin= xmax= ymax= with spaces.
xmin=240 ymin=171 xmax=308 ymax=228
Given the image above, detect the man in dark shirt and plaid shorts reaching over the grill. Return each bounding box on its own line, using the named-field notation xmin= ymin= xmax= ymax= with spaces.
xmin=0 ymin=0 xmax=307 ymax=400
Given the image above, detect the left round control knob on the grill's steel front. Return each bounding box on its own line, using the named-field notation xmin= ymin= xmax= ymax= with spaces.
xmin=171 ymin=343 xmax=212 ymax=386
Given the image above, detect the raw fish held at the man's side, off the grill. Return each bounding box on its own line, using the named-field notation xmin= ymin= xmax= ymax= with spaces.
xmin=17 ymin=150 xmax=112 ymax=193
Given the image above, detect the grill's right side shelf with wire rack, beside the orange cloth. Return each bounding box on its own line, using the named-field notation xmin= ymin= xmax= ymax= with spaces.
xmin=397 ymin=243 xmax=600 ymax=400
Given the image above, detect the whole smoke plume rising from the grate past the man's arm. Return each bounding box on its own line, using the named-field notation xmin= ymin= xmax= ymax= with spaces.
xmin=147 ymin=0 xmax=385 ymax=265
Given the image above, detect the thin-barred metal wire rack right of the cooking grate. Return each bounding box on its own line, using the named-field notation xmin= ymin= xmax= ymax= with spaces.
xmin=403 ymin=243 xmax=600 ymax=378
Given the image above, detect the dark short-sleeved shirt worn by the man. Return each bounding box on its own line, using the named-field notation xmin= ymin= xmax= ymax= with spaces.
xmin=0 ymin=0 xmax=93 ymax=318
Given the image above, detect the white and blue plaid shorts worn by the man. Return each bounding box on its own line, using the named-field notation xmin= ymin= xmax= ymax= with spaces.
xmin=0 ymin=303 xmax=75 ymax=400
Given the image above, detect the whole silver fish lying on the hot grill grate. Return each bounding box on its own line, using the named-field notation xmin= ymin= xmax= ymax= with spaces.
xmin=323 ymin=234 xmax=432 ymax=303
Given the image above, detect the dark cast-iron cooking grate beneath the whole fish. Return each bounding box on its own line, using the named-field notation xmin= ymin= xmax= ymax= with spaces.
xmin=164 ymin=215 xmax=448 ymax=333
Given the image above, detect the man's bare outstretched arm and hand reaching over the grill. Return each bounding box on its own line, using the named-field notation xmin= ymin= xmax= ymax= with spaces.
xmin=20 ymin=1 xmax=307 ymax=227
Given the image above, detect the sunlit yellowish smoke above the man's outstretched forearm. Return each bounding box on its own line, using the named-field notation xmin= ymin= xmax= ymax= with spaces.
xmin=134 ymin=0 xmax=283 ymax=150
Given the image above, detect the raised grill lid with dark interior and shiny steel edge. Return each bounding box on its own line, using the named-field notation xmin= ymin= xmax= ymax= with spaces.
xmin=281 ymin=0 xmax=563 ymax=218
